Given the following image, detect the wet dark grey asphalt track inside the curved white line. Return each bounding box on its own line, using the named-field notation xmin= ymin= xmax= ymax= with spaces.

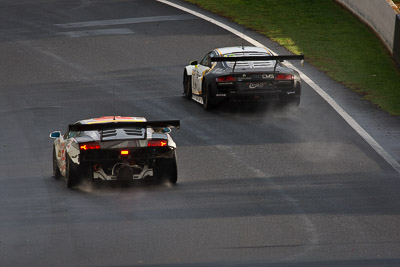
xmin=0 ymin=0 xmax=400 ymax=266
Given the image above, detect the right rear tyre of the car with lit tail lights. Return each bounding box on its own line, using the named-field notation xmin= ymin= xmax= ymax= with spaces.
xmin=154 ymin=156 xmax=178 ymax=184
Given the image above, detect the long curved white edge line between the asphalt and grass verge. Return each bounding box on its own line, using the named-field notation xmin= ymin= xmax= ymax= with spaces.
xmin=157 ymin=0 xmax=400 ymax=173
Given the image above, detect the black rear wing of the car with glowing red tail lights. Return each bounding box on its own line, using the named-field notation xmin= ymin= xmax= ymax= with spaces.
xmin=68 ymin=120 xmax=181 ymax=132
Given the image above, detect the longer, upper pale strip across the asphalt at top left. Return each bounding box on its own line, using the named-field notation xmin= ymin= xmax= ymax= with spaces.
xmin=55 ymin=15 xmax=196 ymax=28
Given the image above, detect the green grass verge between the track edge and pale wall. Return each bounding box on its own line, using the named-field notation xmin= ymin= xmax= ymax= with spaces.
xmin=185 ymin=0 xmax=400 ymax=116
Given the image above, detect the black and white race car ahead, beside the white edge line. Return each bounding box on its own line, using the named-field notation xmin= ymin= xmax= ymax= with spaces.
xmin=183 ymin=46 xmax=304 ymax=109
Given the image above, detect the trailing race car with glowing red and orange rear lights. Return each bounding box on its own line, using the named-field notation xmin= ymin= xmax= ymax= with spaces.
xmin=50 ymin=116 xmax=180 ymax=187
